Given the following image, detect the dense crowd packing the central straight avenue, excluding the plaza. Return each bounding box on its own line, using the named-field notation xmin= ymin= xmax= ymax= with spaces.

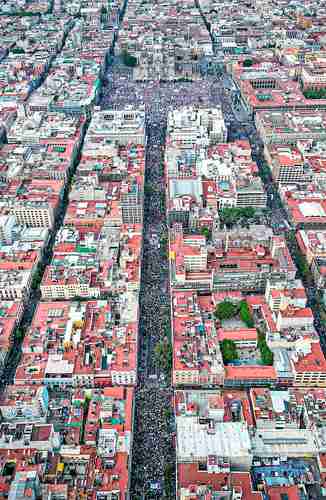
xmin=132 ymin=113 xmax=174 ymax=498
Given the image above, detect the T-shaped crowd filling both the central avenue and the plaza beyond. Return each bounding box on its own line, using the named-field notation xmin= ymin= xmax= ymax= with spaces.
xmin=102 ymin=58 xmax=236 ymax=499
